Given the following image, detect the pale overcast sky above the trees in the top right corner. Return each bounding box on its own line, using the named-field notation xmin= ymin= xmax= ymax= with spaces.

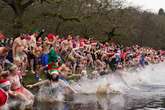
xmin=127 ymin=0 xmax=165 ymax=12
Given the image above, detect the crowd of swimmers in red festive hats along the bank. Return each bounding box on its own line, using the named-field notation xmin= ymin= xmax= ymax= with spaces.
xmin=0 ymin=31 xmax=165 ymax=110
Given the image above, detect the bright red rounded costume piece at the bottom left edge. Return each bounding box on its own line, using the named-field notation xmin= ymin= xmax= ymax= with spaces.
xmin=0 ymin=88 xmax=8 ymax=107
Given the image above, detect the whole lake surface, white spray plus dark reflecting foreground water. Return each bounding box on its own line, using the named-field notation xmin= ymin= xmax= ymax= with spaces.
xmin=31 ymin=63 xmax=165 ymax=110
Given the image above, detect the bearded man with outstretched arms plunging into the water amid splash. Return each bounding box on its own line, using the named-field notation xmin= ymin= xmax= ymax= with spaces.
xmin=27 ymin=70 xmax=77 ymax=102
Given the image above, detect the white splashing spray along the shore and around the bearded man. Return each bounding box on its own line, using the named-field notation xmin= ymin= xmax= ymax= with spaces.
xmin=33 ymin=63 xmax=165 ymax=102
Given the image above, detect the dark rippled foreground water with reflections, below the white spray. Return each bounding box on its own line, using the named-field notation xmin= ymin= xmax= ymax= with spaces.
xmin=34 ymin=94 xmax=165 ymax=110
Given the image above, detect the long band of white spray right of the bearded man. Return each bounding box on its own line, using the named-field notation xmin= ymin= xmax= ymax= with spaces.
xmin=72 ymin=63 xmax=165 ymax=94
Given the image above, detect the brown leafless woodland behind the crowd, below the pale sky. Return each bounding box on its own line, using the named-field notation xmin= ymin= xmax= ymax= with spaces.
xmin=0 ymin=0 xmax=165 ymax=49
